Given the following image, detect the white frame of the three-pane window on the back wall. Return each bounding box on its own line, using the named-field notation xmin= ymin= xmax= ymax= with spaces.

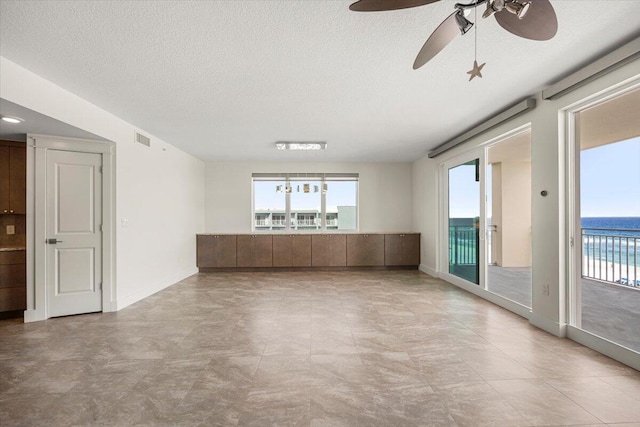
xmin=251 ymin=173 xmax=360 ymax=234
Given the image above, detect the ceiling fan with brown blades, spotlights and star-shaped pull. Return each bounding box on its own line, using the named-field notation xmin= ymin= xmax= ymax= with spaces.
xmin=349 ymin=0 xmax=558 ymax=71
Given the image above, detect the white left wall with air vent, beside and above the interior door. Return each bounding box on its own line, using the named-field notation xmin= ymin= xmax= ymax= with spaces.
xmin=0 ymin=57 xmax=204 ymax=309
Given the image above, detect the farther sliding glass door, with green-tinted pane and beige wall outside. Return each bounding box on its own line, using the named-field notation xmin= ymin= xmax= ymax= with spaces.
xmin=440 ymin=128 xmax=531 ymax=308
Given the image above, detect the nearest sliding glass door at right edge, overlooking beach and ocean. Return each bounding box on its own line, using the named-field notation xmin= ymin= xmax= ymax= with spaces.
xmin=569 ymin=88 xmax=640 ymax=352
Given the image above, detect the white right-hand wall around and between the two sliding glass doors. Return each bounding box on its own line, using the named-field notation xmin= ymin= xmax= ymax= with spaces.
xmin=412 ymin=59 xmax=640 ymax=335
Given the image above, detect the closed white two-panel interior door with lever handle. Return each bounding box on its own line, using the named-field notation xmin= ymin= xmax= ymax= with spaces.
xmin=46 ymin=150 xmax=102 ymax=317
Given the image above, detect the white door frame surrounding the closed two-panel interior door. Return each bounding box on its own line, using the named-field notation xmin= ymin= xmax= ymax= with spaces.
xmin=24 ymin=134 xmax=116 ymax=322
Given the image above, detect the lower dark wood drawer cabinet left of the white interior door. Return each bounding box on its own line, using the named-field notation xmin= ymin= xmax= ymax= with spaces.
xmin=0 ymin=251 xmax=27 ymax=311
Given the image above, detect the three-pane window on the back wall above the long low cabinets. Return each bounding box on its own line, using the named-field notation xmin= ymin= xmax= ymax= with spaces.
xmin=252 ymin=173 xmax=358 ymax=231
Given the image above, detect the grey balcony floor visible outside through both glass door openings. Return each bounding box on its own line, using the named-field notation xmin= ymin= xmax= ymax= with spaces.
xmin=488 ymin=266 xmax=640 ymax=351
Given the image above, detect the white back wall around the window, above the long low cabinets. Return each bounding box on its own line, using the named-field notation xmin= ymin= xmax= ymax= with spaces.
xmin=205 ymin=162 xmax=413 ymax=233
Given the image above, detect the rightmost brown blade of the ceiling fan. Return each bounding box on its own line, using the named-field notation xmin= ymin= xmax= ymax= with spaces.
xmin=495 ymin=0 xmax=558 ymax=41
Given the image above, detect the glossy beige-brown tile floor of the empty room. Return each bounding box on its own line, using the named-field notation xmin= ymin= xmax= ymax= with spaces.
xmin=0 ymin=271 xmax=640 ymax=427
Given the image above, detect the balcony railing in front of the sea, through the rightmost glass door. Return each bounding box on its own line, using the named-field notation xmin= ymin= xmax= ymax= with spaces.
xmin=582 ymin=228 xmax=640 ymax=289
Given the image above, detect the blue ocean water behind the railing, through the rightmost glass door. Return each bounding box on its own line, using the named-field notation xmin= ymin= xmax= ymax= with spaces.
xmin=581 ymin=217 xmax=640 ymax=266
